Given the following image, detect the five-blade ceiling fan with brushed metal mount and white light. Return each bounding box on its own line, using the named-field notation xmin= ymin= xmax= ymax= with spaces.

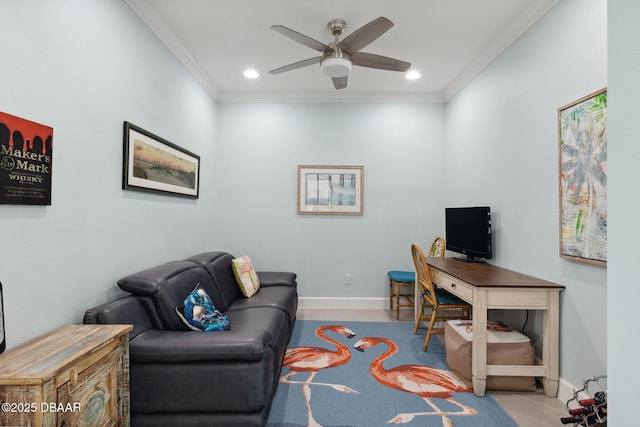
xmin=269 ymin=16 xmax=411 ymax=89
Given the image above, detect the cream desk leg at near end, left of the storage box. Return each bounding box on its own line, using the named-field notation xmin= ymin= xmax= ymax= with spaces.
xmin=471 ymin=288 xmax=487 ymax=396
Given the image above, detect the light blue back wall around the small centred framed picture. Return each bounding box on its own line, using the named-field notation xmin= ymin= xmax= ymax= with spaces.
xmin=216 ymin=103 xmax=444 ymax=298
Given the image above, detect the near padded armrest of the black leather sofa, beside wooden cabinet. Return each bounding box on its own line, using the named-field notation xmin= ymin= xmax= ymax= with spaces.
xmin=129 ymin=329 xmax=272 ymax=363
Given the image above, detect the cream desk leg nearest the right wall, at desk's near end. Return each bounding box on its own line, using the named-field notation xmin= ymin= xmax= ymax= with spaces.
xmin=542 ymin=291 xmax=560 ymax=397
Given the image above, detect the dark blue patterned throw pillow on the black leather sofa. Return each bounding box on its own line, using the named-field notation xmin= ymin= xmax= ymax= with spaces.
xmin=176 ymin=283 xmax=230 ymax=332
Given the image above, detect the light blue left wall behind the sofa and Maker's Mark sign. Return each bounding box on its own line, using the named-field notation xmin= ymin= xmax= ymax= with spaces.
xmin=0 ymin=0 xmax=216 ymax=347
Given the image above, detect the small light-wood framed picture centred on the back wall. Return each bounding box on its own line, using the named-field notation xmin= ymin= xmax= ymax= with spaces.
xmin=298 ymin=165 xmax=364 ymax=215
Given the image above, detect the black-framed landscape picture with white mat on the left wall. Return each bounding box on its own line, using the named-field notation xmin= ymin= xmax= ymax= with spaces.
xmin=122 ymin=122 xmax=200 ymax=198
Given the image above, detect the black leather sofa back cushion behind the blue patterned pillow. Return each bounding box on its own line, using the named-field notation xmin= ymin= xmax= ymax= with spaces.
xmin=118 ymin=261 xmax=222 ymax=331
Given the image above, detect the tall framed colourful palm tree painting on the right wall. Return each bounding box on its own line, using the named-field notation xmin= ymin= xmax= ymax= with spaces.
xmin=558 ymin=88 xmax=607 ymax=265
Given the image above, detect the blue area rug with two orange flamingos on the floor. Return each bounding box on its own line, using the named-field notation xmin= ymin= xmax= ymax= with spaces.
xmin=267 ymin=320 xmax=518 ymax=427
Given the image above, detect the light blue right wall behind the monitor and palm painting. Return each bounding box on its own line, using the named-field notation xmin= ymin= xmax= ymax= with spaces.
xmin=445 ymin=0 xmax=607 ymax=386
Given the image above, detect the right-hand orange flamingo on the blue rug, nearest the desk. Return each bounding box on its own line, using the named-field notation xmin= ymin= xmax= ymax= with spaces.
xmin=354 ymin=337 xmax=478 ymax=427
